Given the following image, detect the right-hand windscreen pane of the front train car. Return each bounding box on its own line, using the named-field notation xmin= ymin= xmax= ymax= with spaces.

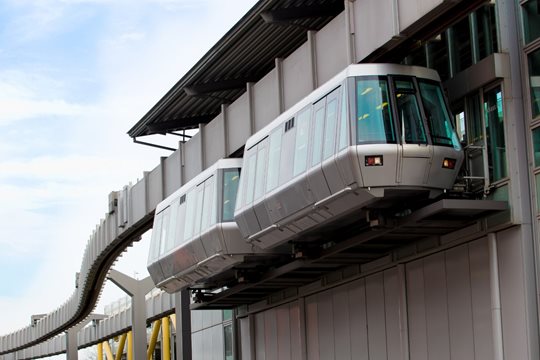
xmin=419 ymin=80 xmax=461 ymax=149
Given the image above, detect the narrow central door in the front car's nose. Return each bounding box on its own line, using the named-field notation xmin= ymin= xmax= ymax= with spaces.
xmin=393 ymin=77 xmax=433 ymax=186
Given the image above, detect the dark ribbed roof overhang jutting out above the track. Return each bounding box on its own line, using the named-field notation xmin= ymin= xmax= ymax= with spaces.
xmin=128 ymin=0 xmax=344 ymax=137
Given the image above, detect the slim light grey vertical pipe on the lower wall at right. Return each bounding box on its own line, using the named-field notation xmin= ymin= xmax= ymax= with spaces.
xmin=488 ymin=233 xmax=504 ymax=360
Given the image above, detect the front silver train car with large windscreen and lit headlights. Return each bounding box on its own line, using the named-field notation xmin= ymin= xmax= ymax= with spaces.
xmin=235 ymin=64 xmax=463 ymax=249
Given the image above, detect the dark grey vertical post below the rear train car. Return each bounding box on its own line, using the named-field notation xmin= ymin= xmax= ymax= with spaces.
xmin=174 ymin=290 xmax=191 ymax=360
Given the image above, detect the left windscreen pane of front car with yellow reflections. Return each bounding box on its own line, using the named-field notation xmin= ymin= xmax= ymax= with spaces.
xmin=356 ymin=77 xmax=396 ymax=144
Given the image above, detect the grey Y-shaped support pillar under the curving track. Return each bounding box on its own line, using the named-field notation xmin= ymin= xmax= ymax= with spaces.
xmin=108 ymin=269 xmax=154 ymax=360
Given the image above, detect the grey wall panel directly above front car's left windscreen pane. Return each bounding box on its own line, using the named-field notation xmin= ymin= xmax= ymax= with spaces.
xmin=353 ymin=0 xmax=397 ymax=60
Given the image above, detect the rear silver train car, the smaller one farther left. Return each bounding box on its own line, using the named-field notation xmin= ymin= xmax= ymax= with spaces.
xmin=148 ymin=159 xmax=270 ymax=293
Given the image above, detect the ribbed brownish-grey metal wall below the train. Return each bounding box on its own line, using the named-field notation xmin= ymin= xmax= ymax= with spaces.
xmin=240 ymin=238 xmax=493 ymax=360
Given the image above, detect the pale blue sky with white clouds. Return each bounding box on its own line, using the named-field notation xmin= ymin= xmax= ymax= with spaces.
xmin=0 ymin=0 xmax=256 ymax=344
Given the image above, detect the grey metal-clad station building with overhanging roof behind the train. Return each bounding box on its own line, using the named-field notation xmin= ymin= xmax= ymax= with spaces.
xmin=125 ymin=0 xmax=540 ymax=360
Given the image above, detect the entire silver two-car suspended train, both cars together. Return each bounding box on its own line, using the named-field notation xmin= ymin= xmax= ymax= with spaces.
xmin=148 ymin=64 xmax=463 ymax=292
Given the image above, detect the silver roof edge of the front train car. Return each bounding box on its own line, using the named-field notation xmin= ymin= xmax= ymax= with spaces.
xmin=246 ymin=63 xmax=440 ymax=150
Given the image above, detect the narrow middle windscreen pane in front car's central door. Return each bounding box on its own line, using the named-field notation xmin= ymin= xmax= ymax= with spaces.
xmin=396 ymin=80 xmax=427 ymax=144
